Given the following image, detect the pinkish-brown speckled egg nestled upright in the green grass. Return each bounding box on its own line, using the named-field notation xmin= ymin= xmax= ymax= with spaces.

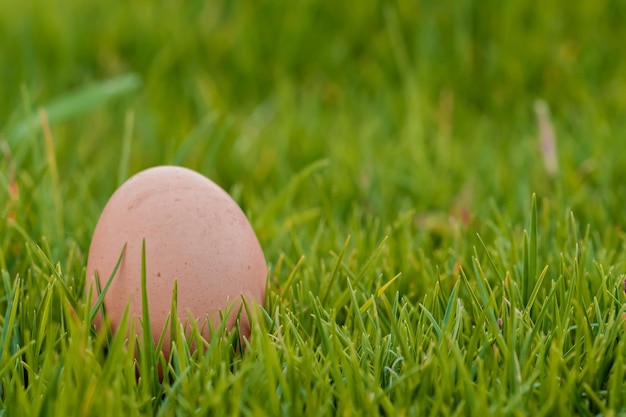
xmin=86 ymin=166 xmax=267 ymax=356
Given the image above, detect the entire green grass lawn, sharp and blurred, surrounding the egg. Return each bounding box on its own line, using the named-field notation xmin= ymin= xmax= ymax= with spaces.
xmin=0 ymin=0 xmax=626 ymax=416
